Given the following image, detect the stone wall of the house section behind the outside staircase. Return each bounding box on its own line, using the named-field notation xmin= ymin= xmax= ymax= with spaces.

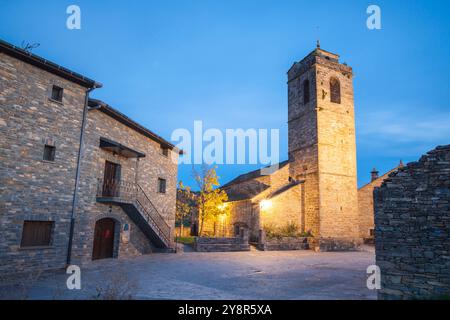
xmin=73 ymin=104 xmax=177 ymax=262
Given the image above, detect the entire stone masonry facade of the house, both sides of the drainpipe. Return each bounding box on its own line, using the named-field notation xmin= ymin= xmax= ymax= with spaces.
xmin=0 ymin=42 xmax=178 ymax=274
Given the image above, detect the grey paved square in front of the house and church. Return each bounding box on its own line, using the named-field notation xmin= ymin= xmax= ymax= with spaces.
xmin=0 ymin=250 xmax=376 ymax=300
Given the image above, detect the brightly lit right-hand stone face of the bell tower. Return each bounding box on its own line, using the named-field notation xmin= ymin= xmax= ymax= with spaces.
xmin=316 ymin=61 xmax=360 ymax=251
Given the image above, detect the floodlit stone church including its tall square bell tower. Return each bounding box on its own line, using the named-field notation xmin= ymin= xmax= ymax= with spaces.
xmin=222 ymin=45 xmax=400 ymax=251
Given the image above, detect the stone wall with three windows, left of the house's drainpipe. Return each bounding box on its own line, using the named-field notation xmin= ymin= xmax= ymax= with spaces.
xmin=0 ymin=53 xmax=86 ymax=273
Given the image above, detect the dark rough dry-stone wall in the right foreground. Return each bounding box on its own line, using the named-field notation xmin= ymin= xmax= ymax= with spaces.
xmin=374 ymin=145 xmax=450 ymax=299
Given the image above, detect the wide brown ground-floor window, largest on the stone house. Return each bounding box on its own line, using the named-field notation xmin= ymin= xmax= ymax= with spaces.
xmin=20 ymin=221 xmax=53 ymax=247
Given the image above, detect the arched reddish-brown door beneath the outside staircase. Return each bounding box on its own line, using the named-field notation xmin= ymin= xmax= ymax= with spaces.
xmin=92 ymin=218 xmax=116 ymax=260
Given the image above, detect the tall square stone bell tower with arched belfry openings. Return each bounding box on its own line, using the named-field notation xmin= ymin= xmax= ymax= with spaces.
xmin=288 ymin=44 xmax=361 ymax=251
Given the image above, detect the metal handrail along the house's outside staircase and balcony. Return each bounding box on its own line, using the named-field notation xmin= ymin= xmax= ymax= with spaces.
xmin=97 ymin=179 xmax=171 ymax=245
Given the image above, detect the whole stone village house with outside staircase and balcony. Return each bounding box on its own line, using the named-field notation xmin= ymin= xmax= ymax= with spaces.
xmin=0 ymin=41 xmax=180 ymax=274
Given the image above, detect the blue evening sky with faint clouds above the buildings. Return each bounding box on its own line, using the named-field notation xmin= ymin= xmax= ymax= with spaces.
xmin=0 ymin=0 xmax=450 ymax=189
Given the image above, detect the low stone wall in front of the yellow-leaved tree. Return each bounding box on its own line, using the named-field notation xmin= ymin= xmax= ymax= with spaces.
xmin=194 ymin=237 xmax=250 ymax=252
